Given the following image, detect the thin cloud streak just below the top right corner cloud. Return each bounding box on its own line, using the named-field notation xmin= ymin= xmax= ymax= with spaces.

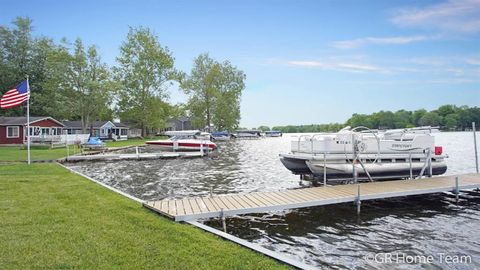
xmin=332 ymin=36 xmax=432 ymax=49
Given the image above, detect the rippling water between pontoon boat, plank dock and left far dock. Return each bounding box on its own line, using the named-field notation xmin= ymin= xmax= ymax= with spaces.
xmin=69 ymin=138 xmax=299 ymax=200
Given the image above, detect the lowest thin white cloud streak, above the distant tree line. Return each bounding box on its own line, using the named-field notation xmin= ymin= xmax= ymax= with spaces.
xmin=287 ymin=60 xmax=390 ymax=73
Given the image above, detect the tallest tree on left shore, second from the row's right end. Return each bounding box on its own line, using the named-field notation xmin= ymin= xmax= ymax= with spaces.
xmin=114 ymin=27 xmax=179 ymax=136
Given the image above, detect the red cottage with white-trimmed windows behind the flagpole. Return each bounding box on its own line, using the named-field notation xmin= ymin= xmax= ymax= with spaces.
xmin=0 ymin=116 xmax=65 ymax=144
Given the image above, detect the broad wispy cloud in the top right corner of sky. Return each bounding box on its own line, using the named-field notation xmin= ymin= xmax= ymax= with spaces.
xmin=391 ymin=0 xmax=480 ymax=33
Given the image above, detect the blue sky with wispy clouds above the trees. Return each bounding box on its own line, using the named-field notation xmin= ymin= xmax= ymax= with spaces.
xmin=0 ymin=0 xmax=480 ymax=128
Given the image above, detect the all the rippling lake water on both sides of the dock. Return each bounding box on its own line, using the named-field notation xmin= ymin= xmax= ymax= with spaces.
xmin=68 ymin=132 xmax=480 ymax=269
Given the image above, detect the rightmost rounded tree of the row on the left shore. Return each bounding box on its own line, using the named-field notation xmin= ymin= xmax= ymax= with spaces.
xmin=181 ymin=54 xmax=245 ymax=130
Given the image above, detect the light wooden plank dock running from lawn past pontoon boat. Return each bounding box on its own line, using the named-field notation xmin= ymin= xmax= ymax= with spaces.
xmin=143 ymin=174 xmax=480 ymax=221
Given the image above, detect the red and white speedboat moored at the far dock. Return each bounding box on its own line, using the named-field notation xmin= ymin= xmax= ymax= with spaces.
xmin=145 ymin=130 xmax=217 ymax=151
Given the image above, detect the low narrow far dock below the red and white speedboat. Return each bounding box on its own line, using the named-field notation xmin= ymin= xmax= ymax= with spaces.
xmin=62 ymin=152 xmax=205 ymax=162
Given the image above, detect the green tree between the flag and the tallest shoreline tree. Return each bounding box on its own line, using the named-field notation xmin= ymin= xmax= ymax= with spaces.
xmin=45 ymin=39 xmax=112 ymax=132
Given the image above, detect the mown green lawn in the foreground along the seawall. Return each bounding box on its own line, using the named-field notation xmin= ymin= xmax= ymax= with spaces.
xmin=0 ymin=163 xmax=286 ymax=269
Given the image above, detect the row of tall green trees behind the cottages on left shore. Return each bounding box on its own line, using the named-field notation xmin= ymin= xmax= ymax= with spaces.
xmin=0 ymin=17 xmax=246 ymax=135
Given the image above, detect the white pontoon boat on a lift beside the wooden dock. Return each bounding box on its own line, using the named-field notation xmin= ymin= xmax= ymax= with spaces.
xmin=280 ymin=127 xmax=447 ymax=181
